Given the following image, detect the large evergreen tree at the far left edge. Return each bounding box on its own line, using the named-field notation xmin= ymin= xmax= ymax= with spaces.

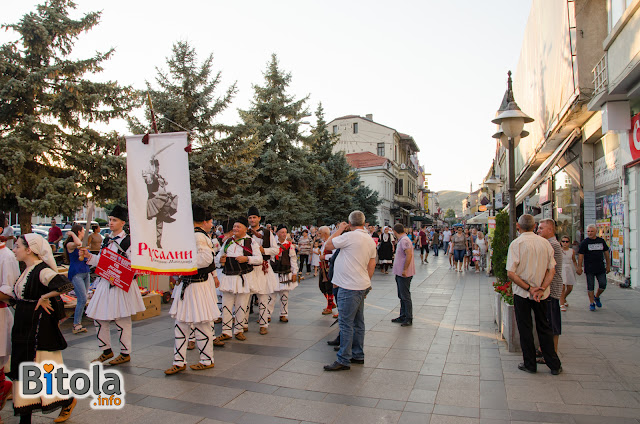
xmin=0 ymin=0 xmax=134 ymax=233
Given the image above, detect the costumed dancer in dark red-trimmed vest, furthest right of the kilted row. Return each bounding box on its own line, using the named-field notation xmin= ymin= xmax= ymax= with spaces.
xmin=271 ymin=225 xmax=298 ymax=322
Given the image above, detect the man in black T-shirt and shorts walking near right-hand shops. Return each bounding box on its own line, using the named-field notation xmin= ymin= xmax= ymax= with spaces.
xmin=578 ymin=224 xmax=611 ymax=311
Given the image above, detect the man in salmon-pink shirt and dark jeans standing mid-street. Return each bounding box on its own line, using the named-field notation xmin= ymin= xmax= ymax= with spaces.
xmin=391 ymin=224 xmax=416 ymax=327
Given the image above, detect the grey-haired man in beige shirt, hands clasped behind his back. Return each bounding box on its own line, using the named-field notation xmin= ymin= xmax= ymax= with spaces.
xmin=506 ymin=214 xmax=562 ymax=375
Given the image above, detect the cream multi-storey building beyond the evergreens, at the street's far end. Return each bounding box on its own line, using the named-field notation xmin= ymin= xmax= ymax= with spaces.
xmin=328 ymin=115 xmax=425 ymax=226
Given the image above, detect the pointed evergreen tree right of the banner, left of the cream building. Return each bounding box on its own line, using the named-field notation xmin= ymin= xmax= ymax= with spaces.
xmin=239 ymin=54 xmax=319 ymax=225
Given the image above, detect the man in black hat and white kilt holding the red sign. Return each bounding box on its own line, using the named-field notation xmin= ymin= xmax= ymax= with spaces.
xmin=86 ymin=205 xmax=146 ymax=365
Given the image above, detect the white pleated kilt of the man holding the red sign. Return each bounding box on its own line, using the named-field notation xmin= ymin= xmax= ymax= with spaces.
xmin=87 ymin=278 xmax=146 ymax=321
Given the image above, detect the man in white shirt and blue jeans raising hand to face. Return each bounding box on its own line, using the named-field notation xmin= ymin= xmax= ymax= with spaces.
xmin=324 ymin=211 xmax=376 ymax=371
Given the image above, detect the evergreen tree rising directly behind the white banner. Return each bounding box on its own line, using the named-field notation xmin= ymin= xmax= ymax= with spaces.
xmin=129 ymin=41 xmax=260 ymax=218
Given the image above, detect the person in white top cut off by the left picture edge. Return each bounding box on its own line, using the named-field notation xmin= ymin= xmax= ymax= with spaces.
xmin=0 ymin=229 xmax=20 ymax=410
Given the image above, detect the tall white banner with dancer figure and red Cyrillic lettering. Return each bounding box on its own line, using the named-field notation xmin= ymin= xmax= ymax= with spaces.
xmin=127 ymin=132 xmax=197 ymax=275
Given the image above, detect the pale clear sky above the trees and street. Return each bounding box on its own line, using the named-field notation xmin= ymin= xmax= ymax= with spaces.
xmin=0 ymin=0 xmax=531 ymax=191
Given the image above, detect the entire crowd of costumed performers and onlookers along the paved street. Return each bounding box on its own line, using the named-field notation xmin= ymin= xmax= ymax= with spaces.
xmin=0 ymin=205 xmax=610 ymax=423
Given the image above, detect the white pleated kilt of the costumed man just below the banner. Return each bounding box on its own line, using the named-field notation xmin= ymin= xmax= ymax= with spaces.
xmin=169 ymin=276 xmax=220 ymax=324
